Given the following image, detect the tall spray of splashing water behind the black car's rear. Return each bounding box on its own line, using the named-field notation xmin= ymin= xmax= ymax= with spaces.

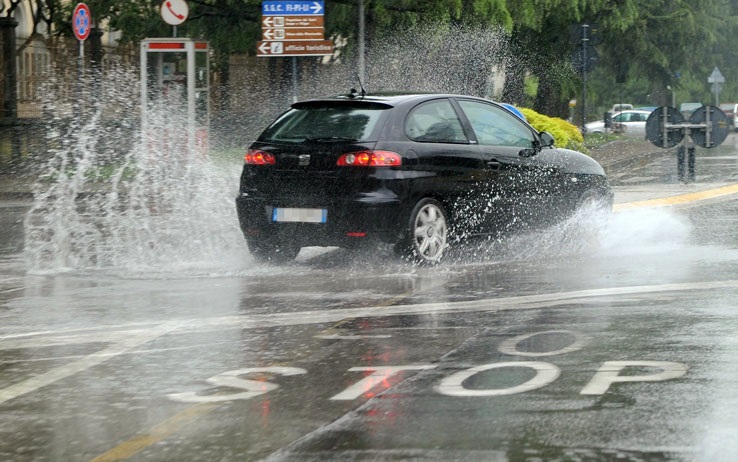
xmin=25 ymin=65 xmax=243 ymax=272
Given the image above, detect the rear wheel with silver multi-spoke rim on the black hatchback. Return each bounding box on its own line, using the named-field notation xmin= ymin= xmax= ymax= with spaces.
xmin=395 ymin=198 xmax=449 ymax=264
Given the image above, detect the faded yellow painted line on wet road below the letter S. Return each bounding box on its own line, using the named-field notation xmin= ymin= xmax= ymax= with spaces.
xmin=90 ymin=403 xmax=222 ymax=462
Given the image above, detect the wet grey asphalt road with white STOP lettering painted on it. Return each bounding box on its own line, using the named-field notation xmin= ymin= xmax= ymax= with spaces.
xmin=0 ymin=135 xmax=738 ymax=461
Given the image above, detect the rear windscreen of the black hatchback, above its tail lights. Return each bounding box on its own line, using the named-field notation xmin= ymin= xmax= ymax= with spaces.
xmin=260 ymin=102 xmax=392 ymax=142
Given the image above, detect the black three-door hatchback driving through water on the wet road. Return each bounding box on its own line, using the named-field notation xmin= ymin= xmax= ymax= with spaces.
xmin=236 ymin=92 xmax=612 ymax=262
